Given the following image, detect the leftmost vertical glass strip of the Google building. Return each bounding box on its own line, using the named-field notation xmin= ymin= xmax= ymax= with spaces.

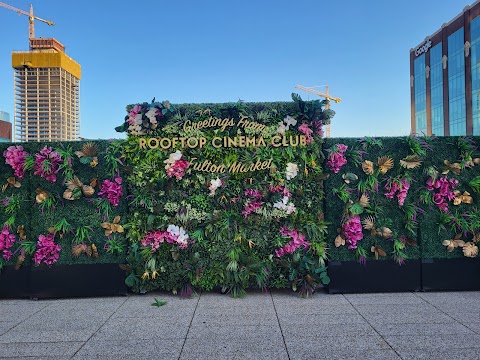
xmin=413 ymin=54 xmax=427 ymax=134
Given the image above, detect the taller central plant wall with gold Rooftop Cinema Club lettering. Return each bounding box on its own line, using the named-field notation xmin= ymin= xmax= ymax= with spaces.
xmin=117 ymin=95 xmax=333 ymax=296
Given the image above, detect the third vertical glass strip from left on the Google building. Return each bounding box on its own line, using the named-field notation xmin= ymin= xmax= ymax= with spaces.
xmin=448 ymin=27 xmax=467 ymax=136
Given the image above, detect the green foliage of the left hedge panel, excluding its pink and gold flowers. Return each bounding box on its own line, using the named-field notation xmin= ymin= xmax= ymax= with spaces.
xmin=0 ymin=141 xmax=127 ymax=266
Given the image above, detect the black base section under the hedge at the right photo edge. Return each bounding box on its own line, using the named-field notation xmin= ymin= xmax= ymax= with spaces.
xmin=422 ymin=257 xmax=480 ymax=291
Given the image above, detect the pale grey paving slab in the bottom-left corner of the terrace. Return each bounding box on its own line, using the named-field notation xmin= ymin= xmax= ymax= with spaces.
xmin=0 ymin=342 xmax=83 ymax=358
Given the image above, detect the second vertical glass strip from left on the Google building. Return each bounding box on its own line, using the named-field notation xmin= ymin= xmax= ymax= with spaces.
xmin=430 ymin=42 xmax=445 ymax=136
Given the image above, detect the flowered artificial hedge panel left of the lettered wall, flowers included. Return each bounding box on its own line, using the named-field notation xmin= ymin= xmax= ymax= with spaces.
xmin=0 ymin=141 xmax=127 ymax=276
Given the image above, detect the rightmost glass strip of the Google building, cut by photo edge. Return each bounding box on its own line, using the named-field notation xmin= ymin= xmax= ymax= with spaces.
xmin=470 ymin=16 xmax=480 ymax=135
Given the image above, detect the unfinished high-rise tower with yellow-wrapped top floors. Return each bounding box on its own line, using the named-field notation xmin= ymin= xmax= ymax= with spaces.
xmin=12 ymin=38 xmax=81 ymax=142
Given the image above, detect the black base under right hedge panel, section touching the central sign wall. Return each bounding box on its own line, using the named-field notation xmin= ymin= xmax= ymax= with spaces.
xmin=326 ymin=260 xmax=421 ymax=294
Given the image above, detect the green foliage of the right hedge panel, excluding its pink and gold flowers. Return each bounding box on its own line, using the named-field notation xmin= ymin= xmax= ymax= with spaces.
xmin=324 ymin=136 xmax=480 ymax=263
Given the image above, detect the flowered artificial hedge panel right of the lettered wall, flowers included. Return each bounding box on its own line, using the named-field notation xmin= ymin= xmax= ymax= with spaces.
xmin=324 ymin=136 xmax=480 ymax=265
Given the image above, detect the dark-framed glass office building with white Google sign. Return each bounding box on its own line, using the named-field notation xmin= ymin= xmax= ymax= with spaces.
xmin=410 ymin=0 xmax=480 ymax=136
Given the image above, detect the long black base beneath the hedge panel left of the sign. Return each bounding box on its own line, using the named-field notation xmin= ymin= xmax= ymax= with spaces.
xmin=0 ymin=264 xmax=127 ymax=299
